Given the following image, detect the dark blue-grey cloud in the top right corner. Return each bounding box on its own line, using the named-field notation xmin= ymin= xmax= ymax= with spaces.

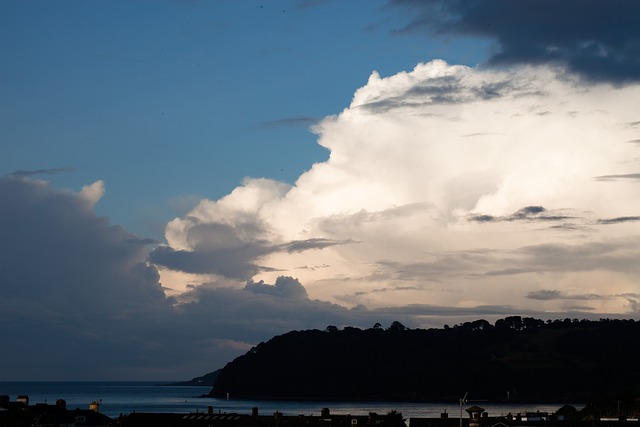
xmin=390 ymin=0 xmax=640 ymax=83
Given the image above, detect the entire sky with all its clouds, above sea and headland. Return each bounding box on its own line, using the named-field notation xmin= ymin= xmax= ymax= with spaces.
xmin=0 ymin=0 xmax=640 ymax=381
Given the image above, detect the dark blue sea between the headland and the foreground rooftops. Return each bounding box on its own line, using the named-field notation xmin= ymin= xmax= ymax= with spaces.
xmin=0 ymin=381 xmax=584 ymax=420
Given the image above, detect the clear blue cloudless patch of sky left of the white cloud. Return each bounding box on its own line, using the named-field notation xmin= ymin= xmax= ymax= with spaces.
xmin=0 ymin=1 xmax=490 ymax=239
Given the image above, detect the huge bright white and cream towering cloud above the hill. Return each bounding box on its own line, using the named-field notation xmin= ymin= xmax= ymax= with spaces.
xmin=152 ymin=61 xmax=640 ymax=313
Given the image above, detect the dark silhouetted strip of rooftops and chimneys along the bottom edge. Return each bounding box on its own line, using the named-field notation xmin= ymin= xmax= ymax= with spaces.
xmin=0 ymin=401 xmax=640 ymax=427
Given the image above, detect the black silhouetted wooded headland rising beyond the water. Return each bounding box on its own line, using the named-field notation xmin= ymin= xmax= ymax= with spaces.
xmin=212 ymin=316 xmax=640 ymax=402
